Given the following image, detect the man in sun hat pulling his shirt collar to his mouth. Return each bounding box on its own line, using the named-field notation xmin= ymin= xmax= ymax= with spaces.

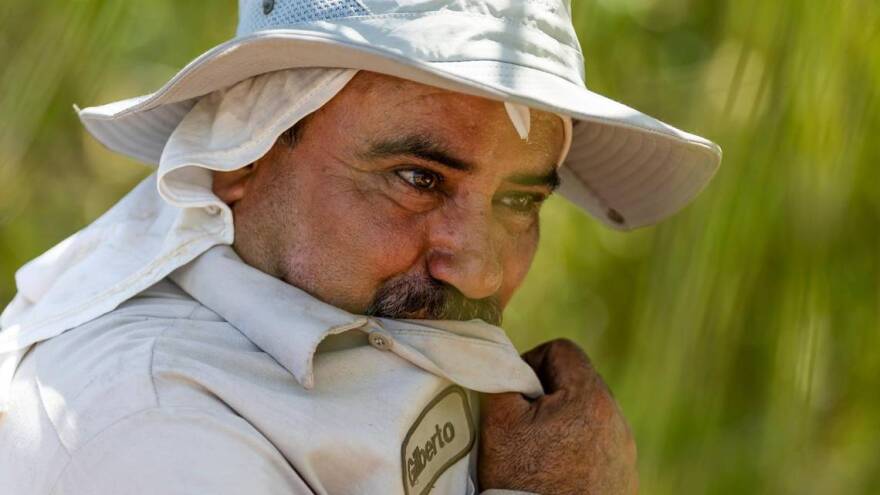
xmin=0 ymin=0 xmax=720 ymax=494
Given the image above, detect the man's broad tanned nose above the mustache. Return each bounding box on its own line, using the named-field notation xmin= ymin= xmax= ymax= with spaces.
xmin=427 ymin=200 xmax=504 ymax=299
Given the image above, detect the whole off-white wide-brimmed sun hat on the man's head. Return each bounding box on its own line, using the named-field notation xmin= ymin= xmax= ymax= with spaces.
xmin=79 ymin=0 xmax=721 ymax=230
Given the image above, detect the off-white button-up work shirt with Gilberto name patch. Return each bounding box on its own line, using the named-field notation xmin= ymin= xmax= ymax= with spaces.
xmin=0 ymin=246 xmax=541 ymax=495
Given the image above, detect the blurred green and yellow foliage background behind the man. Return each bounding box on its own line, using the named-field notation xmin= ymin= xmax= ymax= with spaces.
xmin=0 ymin=0 xmax=880 ymax=495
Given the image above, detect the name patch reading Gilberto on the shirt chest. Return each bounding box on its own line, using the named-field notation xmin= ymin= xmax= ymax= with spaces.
xmin=401 ymin=385 xmax=476 ymax=495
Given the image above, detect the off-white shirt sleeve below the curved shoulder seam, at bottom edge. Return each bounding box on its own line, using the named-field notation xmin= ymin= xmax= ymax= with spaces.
xmin=52 ymin=408 xmax=312 ymax=495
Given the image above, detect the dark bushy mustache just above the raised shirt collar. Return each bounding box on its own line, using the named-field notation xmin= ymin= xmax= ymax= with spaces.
xmin=365 ymin=276 xmax=502 ymax=325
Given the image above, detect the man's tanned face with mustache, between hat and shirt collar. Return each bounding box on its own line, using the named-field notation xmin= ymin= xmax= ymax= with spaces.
xmin=214 ymin=72 xmax=564 ymax=324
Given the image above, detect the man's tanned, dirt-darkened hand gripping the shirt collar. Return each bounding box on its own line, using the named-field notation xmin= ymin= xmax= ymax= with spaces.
xmin=479 ymin=340 xmax=638 ymax=495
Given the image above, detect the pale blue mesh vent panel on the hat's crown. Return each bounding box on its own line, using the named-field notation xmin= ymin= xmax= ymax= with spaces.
xmin=238 ymin=0 xmax=370 ymax=35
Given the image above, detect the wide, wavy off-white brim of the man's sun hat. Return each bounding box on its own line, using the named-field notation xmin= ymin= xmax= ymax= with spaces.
xmin=78 ymin=29 xmax=721 ymax=230
